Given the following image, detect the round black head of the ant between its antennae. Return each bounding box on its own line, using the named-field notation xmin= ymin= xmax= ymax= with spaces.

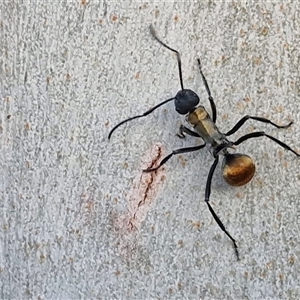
xmin=175 ymin=89 xmax=200 ymax=115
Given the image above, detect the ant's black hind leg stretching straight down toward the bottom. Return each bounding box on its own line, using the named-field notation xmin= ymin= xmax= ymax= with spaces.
xmin=205 ymin=156 xmax=239 ymax=260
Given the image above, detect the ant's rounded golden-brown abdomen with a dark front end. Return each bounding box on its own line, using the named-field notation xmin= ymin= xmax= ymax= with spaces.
xmin=222 ymin=153 xmax=255 ymax=186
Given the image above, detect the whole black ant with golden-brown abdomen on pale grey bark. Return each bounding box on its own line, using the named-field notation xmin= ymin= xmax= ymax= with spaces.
xmin=108 ymin=25 xmax=300 ymax=260
